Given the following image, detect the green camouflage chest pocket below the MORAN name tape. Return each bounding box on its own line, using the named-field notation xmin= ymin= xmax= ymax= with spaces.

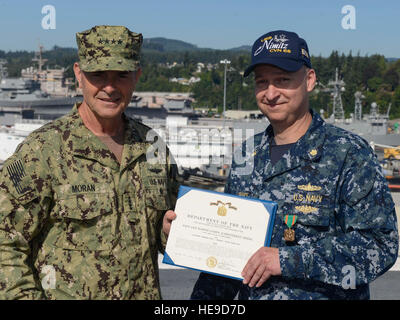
xmin=53 ymin=188 xmax=119 ymax=250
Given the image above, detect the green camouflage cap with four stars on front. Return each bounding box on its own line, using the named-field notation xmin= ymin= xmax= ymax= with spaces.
xmin=76 ymin=26 xmax=143 ymax=72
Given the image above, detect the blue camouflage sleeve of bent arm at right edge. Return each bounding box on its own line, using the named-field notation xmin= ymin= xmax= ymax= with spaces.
xmin=279 ymin=148 xmax=399 ymax=289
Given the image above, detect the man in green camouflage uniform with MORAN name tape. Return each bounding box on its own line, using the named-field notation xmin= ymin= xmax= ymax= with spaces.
xmin=0 ymin=26 xmax=177 ymax=299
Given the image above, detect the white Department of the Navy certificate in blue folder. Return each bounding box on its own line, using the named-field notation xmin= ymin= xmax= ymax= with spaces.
xmin=163 ymin=186 xmax=277 ymax=279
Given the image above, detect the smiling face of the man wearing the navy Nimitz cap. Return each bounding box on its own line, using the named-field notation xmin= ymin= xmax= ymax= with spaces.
xmin=254 ymin=64 xmax=316 ymax=125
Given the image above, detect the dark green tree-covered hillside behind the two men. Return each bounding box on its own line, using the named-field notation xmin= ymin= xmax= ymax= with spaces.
xmin=0 ymin=45 xmax=400 ymax=119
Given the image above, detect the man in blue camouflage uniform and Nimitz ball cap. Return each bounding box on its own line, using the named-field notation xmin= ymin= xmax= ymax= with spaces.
xmin=192 ymin=31 xmax=398 ymax=299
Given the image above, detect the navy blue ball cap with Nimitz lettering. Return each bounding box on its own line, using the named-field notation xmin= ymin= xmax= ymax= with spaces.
xmin=244 ymin=30 xmax=311 ymax=77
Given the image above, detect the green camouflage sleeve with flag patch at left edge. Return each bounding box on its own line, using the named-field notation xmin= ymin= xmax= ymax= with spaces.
xmin=0 ymin=141 xmax=50 ymax=299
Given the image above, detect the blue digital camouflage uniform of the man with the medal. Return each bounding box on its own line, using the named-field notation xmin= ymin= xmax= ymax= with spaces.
xmin=192 ymin=112 xmax=399 ymax=299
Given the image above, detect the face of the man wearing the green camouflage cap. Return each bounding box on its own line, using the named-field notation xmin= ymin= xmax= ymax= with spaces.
xmin=74 ymin=63 xmax=141 ymax=119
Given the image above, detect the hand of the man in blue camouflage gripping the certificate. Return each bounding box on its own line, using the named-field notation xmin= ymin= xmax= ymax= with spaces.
xmin=242 ymin=247 xmax=282 ymax=287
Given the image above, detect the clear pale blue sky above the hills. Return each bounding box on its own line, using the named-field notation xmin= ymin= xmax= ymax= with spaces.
xmin=0 ymin=0 xmax=400 ymax=58
